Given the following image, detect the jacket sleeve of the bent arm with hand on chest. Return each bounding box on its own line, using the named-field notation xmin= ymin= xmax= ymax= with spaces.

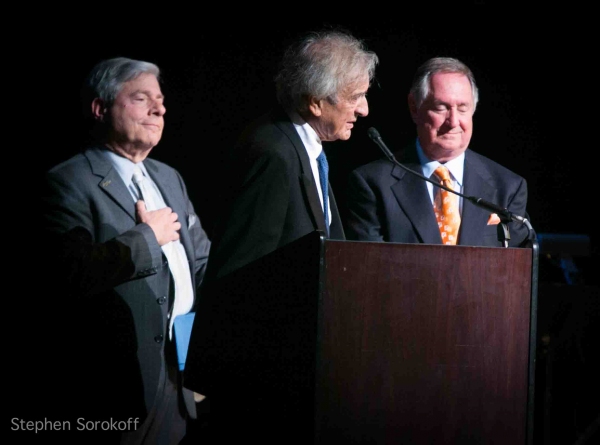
xmin=42 ymin=168 xmax=164 ymax=296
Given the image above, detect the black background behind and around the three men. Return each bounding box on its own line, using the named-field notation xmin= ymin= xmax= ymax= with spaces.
xmin=16 ymin=12 xmax=600 ymax=445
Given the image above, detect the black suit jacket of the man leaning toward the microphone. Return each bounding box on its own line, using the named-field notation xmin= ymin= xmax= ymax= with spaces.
xmin=207 ymin=105 xmax=344 ymax=281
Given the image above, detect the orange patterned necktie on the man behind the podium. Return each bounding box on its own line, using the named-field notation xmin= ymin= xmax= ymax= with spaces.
xmin=433 ymin=165 xmax=460 ymax=245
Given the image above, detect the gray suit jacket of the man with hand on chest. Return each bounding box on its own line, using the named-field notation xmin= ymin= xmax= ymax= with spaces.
xmin=43 ymin=148 xmax=210 ymax=423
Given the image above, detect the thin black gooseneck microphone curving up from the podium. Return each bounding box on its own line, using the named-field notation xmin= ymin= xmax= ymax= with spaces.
xmin=368 ymin=127 xmax=535 ymax=247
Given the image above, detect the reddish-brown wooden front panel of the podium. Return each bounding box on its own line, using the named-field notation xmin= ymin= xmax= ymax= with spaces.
xmin=315 ymin=240 xmax=532 ymax=445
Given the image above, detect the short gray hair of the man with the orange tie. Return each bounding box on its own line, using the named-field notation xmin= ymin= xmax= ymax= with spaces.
xmin=410 ymin=57 xmax=479 ymax=112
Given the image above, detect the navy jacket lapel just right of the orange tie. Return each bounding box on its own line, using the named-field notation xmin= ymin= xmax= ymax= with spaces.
xmin=458 ymin=150 xmax=496 ymax=246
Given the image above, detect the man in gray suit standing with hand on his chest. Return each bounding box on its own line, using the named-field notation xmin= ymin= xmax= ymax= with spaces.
xmin=43 ymin=58 xmax=210 ymax=445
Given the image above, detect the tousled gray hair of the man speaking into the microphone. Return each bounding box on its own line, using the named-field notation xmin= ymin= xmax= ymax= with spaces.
xmin=275 ymin=30 xmax=379 ymax=111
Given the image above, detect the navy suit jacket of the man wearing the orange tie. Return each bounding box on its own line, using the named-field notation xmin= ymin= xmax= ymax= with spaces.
xmin=345 ymin=144 xmax=529 ymax=247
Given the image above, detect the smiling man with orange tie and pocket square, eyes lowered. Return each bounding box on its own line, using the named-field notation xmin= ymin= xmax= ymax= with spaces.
xmin=344 ymin=57 xmax=530 ymax=247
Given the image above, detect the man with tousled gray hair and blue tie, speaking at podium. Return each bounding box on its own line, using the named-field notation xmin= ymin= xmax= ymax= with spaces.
xmin=207 ymin=30 xmax=378 ymax=279
